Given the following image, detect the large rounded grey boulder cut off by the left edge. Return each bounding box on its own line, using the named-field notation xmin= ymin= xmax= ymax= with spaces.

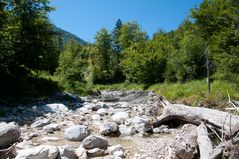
xmin=0 ymin=123 xmax=21 ymax=148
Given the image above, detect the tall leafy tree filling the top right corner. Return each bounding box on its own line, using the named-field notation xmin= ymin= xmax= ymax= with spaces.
xmin=192 ymin=0 xmax=239 ymax=79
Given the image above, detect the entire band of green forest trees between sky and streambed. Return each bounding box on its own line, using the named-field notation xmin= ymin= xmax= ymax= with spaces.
xmin=0 ymin=0 xmax=239 ymax=95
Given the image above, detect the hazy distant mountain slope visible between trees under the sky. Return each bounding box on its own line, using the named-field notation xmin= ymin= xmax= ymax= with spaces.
xmin=53 ymin=25 xmax=87 ymax=45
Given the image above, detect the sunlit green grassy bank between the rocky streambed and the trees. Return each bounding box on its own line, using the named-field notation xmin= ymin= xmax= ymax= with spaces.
xmin=93 ymin=80 xmax=239 ymax=109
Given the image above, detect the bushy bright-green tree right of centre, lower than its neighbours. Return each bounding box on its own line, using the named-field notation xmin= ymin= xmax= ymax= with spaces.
xmin=121 ymin=32 xmax=172 ymax=84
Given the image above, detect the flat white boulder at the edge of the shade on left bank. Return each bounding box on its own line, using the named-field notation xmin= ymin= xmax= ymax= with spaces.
xmin=43 ymin=103 xmax=69 ymax=113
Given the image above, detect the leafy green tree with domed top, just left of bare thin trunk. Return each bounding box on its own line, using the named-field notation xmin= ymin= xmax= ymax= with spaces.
xmin=165 ymin=20 xmax=206 ymax=82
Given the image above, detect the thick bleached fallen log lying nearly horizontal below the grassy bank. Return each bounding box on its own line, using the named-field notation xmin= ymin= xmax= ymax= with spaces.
xmin=152 ymin=101 xmax=239 ymax=138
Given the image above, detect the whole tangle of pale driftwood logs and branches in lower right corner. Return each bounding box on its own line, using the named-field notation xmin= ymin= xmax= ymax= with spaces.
xmin=152 ymin=97 xmax=239 ymax=159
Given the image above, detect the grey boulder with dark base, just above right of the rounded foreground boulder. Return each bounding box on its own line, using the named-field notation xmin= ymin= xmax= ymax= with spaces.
xmin=100 ymin=122 xmax=120 ymax=136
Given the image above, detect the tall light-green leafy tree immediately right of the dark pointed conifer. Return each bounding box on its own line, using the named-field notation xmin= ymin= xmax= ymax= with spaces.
xmin=119 ymin=22 xmax=148 ymax=82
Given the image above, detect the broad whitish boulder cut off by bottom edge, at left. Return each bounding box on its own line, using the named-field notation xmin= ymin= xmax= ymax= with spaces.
xmin=15 ymin=145 xmax=59 ymax=159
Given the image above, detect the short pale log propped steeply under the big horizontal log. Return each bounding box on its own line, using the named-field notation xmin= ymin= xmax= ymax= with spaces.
xmin=197 ymin=123 xmax=213 ymax=159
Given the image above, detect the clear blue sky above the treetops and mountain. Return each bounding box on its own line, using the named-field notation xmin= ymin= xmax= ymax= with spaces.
xmin=49 ymin=0 xmax=202 ymax=42
